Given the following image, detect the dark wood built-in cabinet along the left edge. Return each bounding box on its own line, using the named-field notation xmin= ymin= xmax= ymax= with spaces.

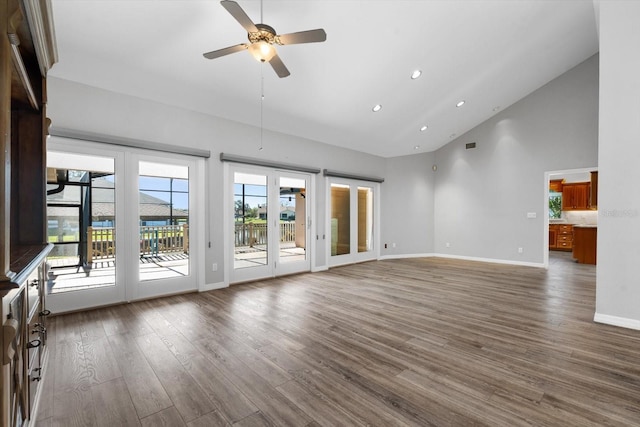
xmin=0 ymin=0 xmax=57 ymax=427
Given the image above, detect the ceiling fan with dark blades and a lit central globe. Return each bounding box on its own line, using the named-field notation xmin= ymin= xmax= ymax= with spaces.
xmin=203 ymin=0 xmax=327 ymax=78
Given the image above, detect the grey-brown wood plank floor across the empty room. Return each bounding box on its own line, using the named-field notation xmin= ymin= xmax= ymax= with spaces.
xmin=37 ymin=254 xmax=640 ymax=427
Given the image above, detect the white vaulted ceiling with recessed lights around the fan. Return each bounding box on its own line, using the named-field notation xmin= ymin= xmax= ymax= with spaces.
xmin=50 ymin=0 xmax=598 ymax=157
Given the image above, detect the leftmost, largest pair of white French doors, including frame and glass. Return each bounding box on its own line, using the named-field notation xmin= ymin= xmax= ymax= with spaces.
xmin=47 ymin=138 xmax=203 ymax=312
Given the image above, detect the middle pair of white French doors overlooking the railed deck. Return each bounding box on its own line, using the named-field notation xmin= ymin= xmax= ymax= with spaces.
xmin=227 ymin=166 xmax=312 ymax=283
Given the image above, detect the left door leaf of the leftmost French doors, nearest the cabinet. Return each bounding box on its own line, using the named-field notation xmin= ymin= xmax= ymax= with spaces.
xmin=47 ymin=147 xmax=122 ymax=311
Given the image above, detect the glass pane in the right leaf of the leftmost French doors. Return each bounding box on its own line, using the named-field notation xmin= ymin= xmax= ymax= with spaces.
xmin=138 ymin=161 xmax=190 ymax=282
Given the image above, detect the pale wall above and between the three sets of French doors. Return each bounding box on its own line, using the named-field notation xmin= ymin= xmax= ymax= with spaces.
xmin=47 ymin=78 xmax=385 ymax=284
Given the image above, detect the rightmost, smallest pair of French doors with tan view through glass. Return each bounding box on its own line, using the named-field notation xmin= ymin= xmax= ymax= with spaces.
xmin=327 ymin=178 xmax=380 ymax=266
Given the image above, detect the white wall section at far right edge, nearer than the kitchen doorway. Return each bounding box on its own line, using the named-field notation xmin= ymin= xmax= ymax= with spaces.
xmin=595 ymin=0 xmax=640 ymax=329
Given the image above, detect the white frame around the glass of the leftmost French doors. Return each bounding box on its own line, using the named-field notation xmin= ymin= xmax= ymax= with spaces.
xmin=47 ymin=137 xmax=205 ymax=313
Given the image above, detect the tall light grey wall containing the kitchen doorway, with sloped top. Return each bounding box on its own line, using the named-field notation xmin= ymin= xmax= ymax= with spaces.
xmin=425 ymin=55 xmax=598 ymax=265
